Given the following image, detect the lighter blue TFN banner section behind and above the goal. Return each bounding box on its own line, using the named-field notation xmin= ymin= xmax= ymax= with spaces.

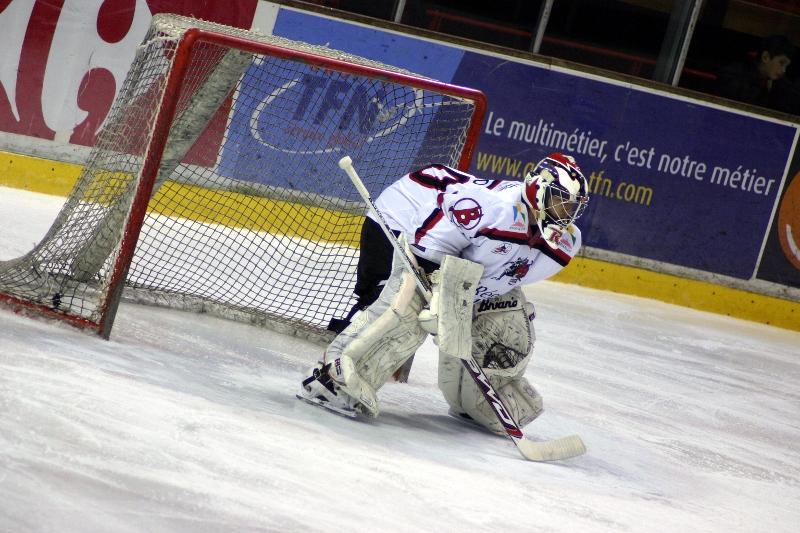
xmin=218 ymin=9 xmax=472 ymax=198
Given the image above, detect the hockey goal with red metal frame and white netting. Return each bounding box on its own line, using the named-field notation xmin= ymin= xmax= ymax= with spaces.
xmin=0 ymin=15 xmax=485 ymax=340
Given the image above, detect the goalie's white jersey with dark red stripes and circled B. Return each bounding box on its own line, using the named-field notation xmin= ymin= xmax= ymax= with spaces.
xmin=370 ymin=165 xmax=581 ymax=301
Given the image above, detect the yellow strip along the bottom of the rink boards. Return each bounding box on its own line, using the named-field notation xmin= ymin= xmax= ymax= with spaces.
xmin=0 ymin=152 xmax=800 ymax=331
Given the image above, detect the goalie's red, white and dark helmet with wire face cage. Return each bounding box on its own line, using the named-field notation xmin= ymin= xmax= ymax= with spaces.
xmin=522 ymin=153 xmax=589 ymax=240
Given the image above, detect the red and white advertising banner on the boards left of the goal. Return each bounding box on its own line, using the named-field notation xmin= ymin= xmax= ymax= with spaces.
xmin=0 ymin=0 xmax=257 ymax=146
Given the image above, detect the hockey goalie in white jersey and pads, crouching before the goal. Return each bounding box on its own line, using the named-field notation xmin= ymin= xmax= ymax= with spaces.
xmin=298 ymin=153 xmax=588 ymax=434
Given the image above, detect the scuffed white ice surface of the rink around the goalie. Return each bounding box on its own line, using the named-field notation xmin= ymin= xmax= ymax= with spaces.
xmin=0 ymin=188 xmax=800 ymax=532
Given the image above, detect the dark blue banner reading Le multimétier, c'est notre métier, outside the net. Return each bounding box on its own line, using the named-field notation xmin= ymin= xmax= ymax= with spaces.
xmin=273 ymin=10 xmax=796 ymax=279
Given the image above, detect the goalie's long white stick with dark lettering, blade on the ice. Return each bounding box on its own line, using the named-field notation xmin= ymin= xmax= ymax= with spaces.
xmin=339 ymin=156 xmax=586 ymax=461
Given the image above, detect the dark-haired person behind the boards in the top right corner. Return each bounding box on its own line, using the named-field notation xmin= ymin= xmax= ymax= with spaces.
xmin=717 ymin=35 xmax=794 ymax=111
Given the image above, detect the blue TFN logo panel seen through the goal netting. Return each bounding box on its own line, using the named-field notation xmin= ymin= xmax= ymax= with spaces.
xmin=218 ymin=58 xmax=438 ymax=195
